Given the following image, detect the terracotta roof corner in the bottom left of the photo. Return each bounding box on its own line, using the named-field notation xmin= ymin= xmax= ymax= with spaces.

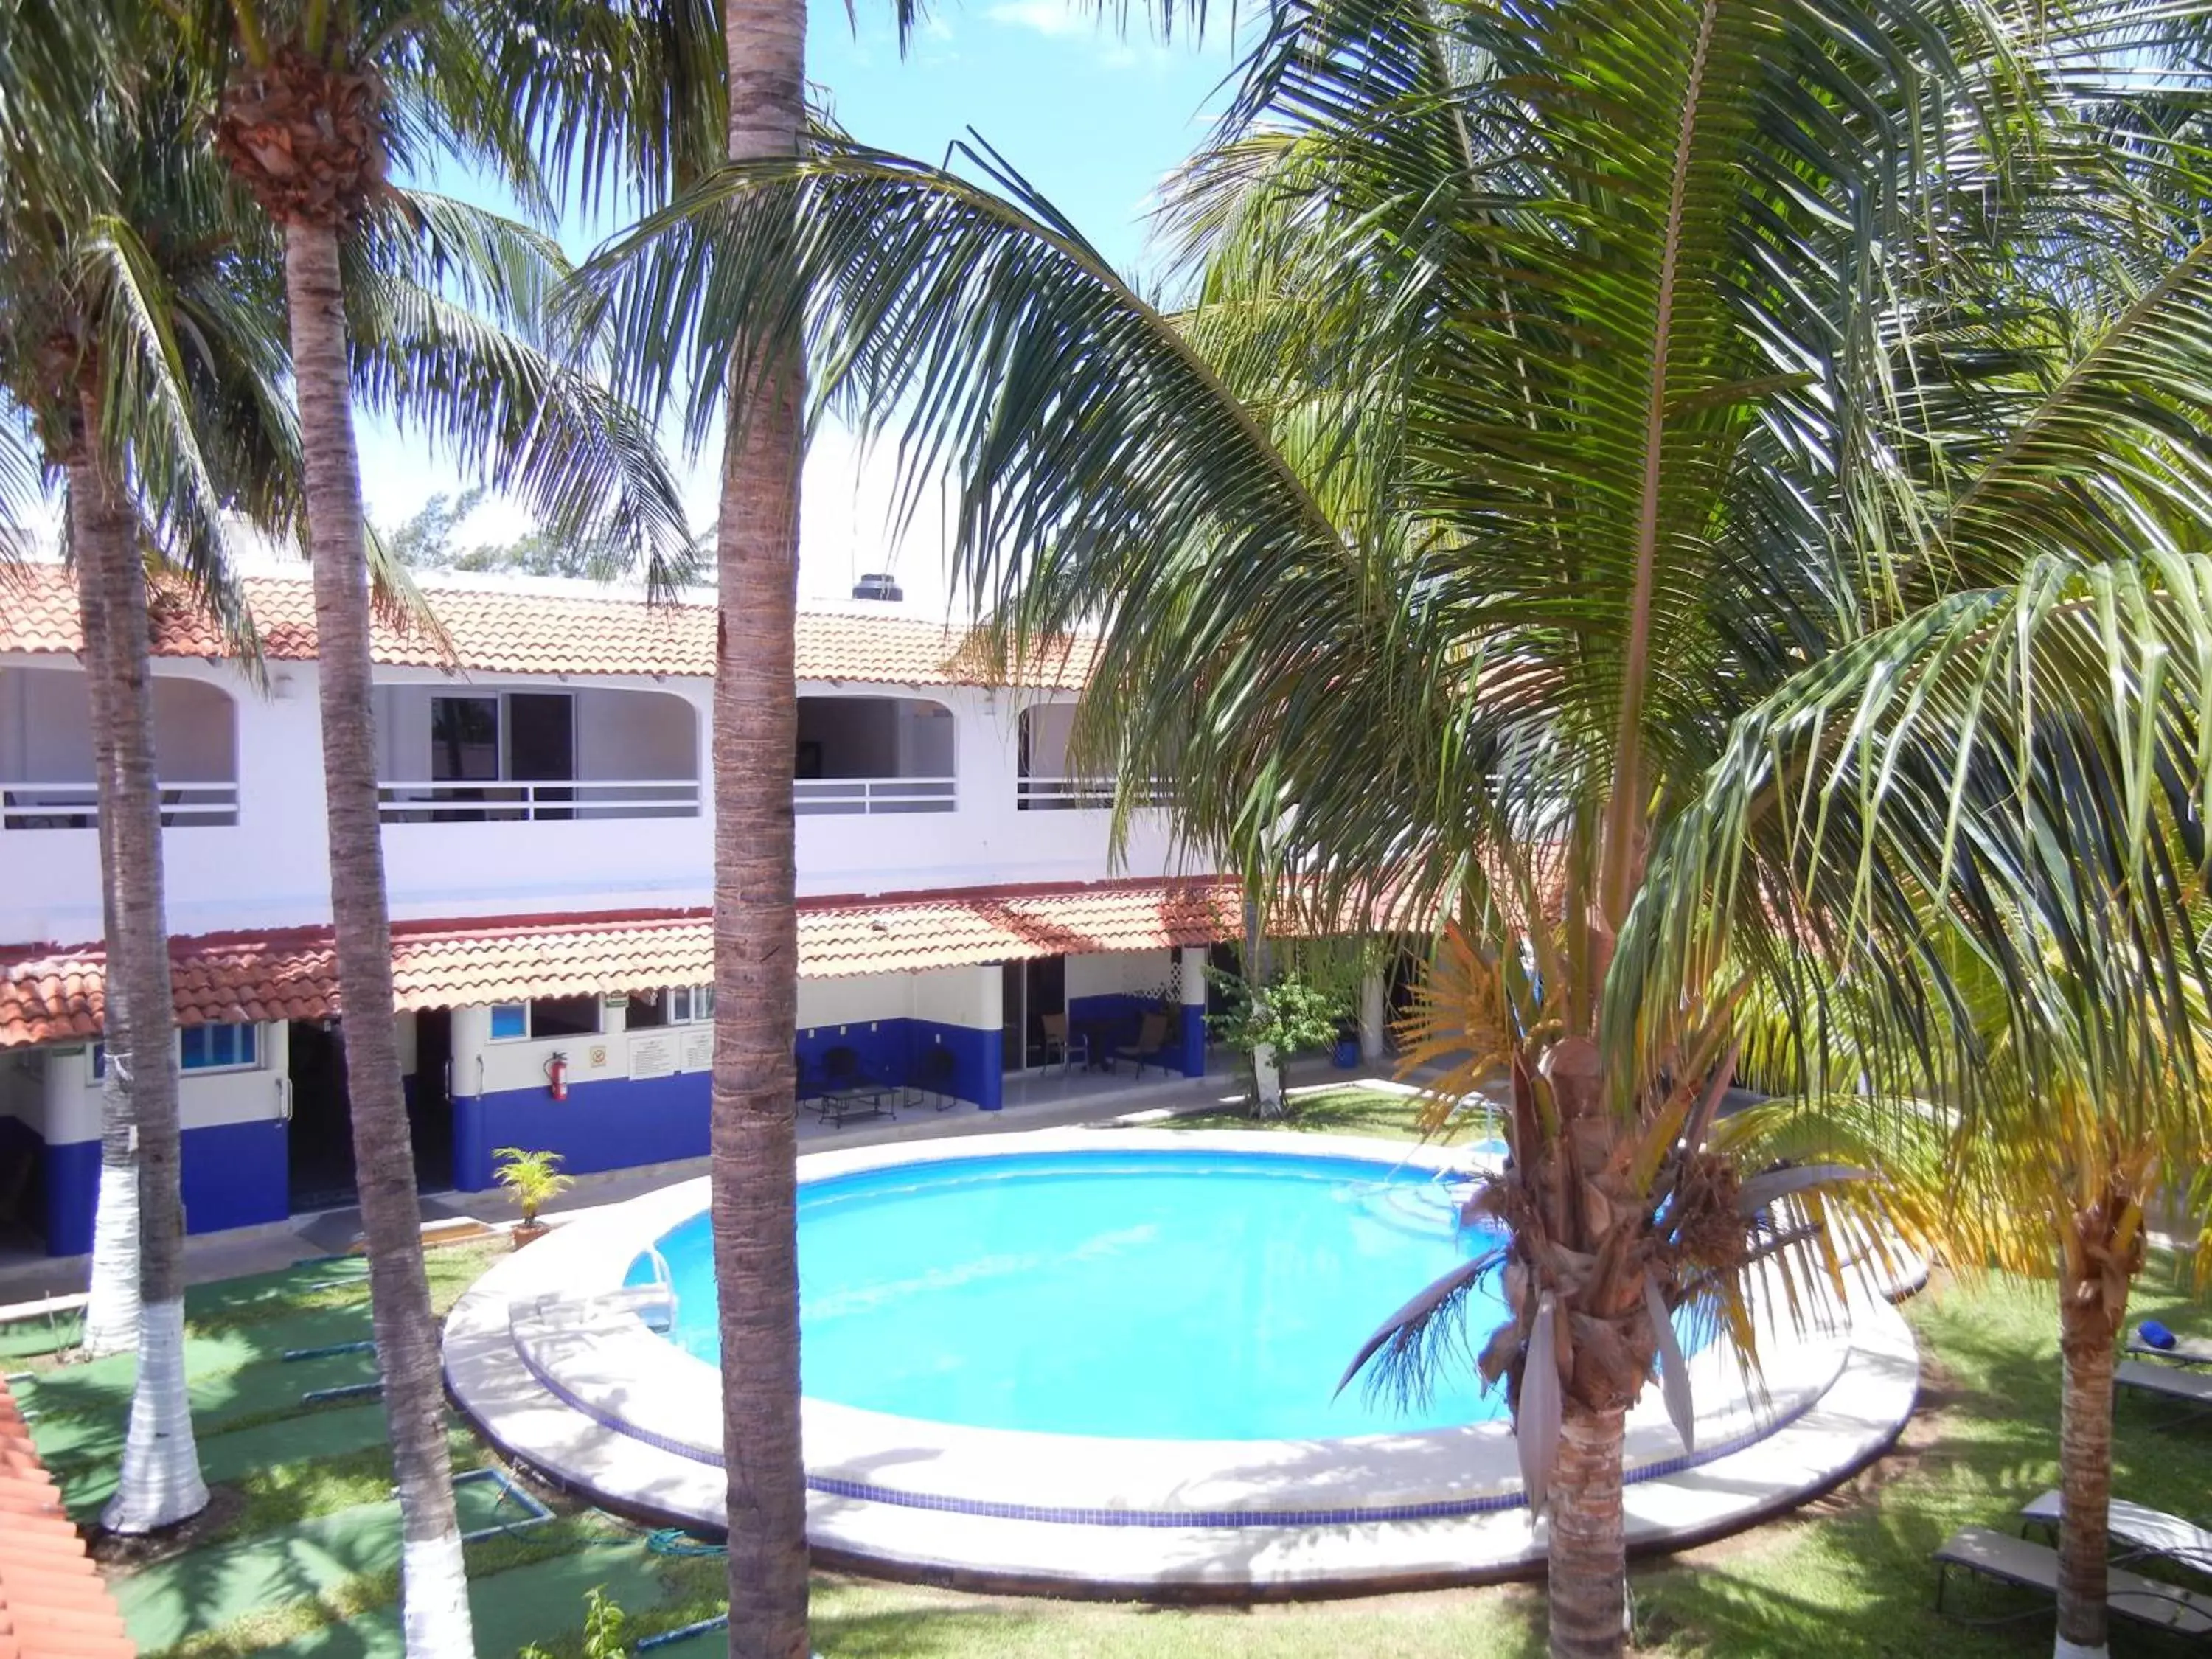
xmin=0 ymin=1382 xmax=137 ymax=1659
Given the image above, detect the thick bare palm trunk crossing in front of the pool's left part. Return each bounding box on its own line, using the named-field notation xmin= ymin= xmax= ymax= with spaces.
xmin=712 ymin=0 xmax=807 ymax=1659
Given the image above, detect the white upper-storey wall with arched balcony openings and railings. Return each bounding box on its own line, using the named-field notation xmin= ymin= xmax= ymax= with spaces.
xmin=0 ymin=657 xmax=1212 ymax=945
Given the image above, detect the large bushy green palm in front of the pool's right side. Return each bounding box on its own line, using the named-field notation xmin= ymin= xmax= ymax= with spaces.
xmin=584 ymin=0 xmax=2212 ymax=1655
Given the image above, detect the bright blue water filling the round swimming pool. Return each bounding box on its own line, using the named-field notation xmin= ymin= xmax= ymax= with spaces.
xmin=630 ymin=1150 xmax=1504 ymax=1440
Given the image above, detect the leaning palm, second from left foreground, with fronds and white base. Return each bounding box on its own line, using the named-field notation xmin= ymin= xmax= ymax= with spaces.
xmin=149 ymin=0 xmax=688 ymax=1655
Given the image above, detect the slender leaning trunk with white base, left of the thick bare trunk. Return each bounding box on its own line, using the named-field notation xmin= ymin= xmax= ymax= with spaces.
xmin=285 ymin=219 xmax=476 ymax=1659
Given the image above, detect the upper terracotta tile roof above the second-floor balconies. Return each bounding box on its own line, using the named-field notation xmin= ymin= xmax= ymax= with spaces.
xmin=0 ymin=564 xmax=1091 ymax=690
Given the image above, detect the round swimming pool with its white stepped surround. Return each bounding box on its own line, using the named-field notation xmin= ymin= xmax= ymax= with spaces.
xmin=445 ymin=1128 xmax=1918 ymax=1595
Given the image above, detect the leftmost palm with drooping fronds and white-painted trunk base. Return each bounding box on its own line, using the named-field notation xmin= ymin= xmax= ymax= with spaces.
xmin=0 ymin=26 xmax=296 ymax=1533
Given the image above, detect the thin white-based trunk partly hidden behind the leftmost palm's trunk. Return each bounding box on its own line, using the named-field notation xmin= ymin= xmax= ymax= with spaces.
xmin=69 ymin=520 xmax=139 ymax=1358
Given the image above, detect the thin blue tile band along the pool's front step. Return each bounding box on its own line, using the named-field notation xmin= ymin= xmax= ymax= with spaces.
xmin=513 ymin=1343 xmax=1834 ymax=1528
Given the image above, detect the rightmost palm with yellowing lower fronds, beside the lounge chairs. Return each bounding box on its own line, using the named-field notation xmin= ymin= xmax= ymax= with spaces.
xmin=1655 ymin=699 xmax=2212 ymax=1659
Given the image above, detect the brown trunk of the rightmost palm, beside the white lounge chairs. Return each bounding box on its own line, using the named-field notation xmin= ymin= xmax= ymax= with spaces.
xmin=2053 ymin=1274 xmax=2119 ymax=1659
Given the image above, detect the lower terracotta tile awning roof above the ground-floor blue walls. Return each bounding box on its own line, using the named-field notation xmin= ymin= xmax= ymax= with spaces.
xmin=0 ymin=880 xmax=1241 ymax=1048
